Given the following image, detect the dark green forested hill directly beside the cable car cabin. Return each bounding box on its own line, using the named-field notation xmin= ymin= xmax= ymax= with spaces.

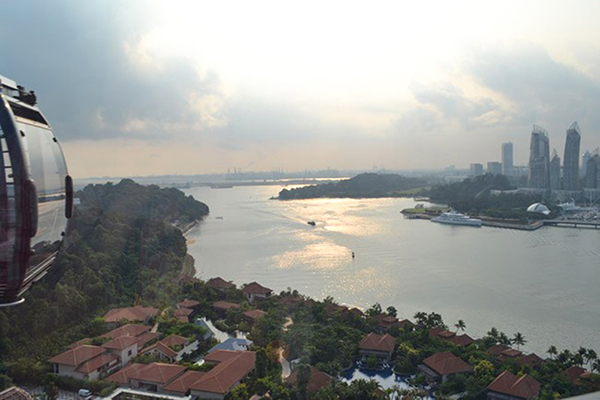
xmin=0 ymin=180 xmax=208 ymax=374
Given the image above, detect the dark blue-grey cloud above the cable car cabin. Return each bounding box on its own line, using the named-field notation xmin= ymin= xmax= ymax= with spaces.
xmin=0 ymin=1 xmax=226 ymax=141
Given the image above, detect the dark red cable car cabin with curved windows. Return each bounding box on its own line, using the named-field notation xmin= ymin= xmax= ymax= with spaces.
xmin=0 ymin=76 xmax=73 ymax=306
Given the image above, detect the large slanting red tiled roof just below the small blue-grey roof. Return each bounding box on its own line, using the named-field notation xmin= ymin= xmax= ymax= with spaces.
xmin=190 ymin=350 xmax=256 ymax=394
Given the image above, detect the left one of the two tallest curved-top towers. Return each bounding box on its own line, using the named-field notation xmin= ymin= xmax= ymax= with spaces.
xmin=529 ymin=125 xmax=550 ymax=189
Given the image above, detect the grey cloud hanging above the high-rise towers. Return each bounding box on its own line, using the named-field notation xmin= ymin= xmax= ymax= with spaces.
xmin=464 ymin=43 xmax=600 ymax=132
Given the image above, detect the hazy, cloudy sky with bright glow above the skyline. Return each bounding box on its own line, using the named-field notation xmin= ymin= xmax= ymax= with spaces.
xmin=0 ymin=0 xmax=600 ymax=178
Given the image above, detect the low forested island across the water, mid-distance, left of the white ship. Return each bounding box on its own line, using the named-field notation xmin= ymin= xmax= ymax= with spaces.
xmin=277 ymin=173 xmax=427 ymax=200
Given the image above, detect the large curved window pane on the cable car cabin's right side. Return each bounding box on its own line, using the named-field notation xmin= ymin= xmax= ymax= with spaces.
xmin=17 ymin=123 xmax=67 ymax=267
